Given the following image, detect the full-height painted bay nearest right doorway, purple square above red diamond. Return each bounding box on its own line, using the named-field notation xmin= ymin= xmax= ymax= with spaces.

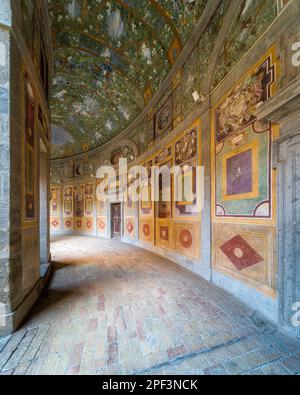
xmin=212 ymin=45 xmax=279 ymax=297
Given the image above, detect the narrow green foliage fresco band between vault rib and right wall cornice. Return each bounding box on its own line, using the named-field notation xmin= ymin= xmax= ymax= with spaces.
xmin=134 ymin=0 xmax=281 ymax=156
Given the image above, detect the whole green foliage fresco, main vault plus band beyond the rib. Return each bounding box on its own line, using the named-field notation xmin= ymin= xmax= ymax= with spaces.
xmin=50 ymin=0 xmax=287 ymax=158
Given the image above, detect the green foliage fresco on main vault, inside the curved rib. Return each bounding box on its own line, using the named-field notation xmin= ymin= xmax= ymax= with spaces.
xmin=49 ymin=0 xmax=207 ymax=158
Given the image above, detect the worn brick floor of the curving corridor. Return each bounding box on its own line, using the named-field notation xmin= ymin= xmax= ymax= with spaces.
xmin=0 ymin=236 xmax=300 ymax=375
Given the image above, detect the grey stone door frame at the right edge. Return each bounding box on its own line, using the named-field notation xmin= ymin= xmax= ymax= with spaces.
xmin=273 ymin=129 xmax=300 ymax=336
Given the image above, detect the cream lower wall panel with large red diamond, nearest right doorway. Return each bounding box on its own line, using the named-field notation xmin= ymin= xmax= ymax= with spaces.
xmin=213 ymin=223 xmax=277 ymax=297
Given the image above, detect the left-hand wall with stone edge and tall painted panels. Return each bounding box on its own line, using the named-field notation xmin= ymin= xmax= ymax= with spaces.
xmin=0 ymin=0 xmax=51 ymax=334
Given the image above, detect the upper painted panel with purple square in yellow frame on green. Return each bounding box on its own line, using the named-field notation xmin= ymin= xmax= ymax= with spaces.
xmin=214 ymin=48 xmax=276 ymax=218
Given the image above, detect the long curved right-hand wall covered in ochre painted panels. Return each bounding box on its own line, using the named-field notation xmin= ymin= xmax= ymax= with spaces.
xmin=52 ymin=0 xmax=300 ymax=330
